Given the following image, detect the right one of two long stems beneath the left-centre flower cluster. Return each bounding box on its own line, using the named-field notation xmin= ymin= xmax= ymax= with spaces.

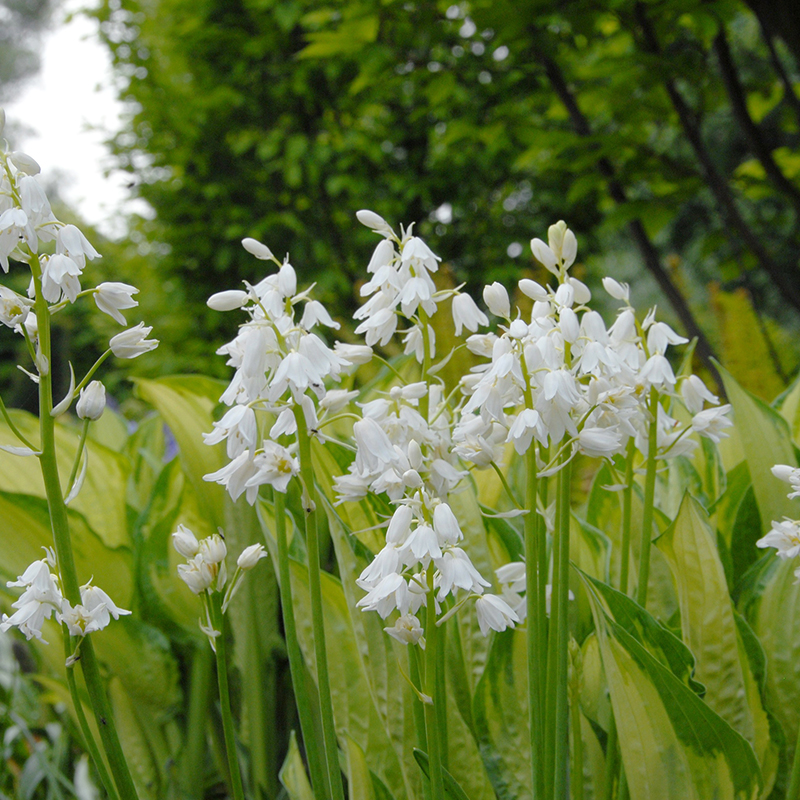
xmin=294 ymin=405 xmax=344 ymax=800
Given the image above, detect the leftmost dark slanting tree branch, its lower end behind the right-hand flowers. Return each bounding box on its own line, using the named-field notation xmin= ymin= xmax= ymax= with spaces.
xmin=542 ymin=57 xmax=722 ymax=378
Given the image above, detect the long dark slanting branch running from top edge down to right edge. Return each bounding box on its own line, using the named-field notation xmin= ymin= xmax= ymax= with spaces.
xmin=634 ymin=3 xmax=800 ymax=311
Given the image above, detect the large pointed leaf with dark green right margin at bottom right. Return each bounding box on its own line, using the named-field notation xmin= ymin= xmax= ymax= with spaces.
xmin=592 ymin=588 xmax=760 ymax=800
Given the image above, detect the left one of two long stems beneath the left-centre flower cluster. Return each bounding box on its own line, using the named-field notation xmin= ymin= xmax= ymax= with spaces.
xmin=273 ymin=491 xmax=327 ymax=800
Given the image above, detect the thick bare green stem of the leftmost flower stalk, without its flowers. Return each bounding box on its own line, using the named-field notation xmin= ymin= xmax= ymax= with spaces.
xmin=31 ymin=255 xmax=137 ymax=800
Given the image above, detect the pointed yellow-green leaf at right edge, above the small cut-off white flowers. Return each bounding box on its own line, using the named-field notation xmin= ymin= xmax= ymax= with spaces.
xmin=720 ymin=367 xmax=797 ymax=533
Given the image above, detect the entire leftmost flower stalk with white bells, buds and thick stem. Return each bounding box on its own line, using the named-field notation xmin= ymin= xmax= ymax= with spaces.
xmin=0 ymin=111 xmax=164 ymax=800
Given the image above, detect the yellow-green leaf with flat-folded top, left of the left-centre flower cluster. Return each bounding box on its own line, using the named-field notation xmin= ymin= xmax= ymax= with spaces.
xmin=136 ymin=375 xmax=227 ymax=530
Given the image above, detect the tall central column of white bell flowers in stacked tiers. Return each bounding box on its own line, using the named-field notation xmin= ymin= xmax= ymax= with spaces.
xmin=335 ymin=211 xmax=519 ymax=647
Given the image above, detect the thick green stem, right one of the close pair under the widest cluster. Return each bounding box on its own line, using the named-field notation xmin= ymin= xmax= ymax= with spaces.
xmin=548 ymin=454 xmax=572 ymax=800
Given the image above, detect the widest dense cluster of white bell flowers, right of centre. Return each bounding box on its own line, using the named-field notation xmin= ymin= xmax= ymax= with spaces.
xmin=453 ymin=222 xmax=732 ymax=474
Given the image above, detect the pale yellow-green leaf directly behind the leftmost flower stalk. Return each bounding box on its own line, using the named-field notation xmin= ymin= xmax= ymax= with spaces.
xmin=0 ymin=411 xmax=130 ymax=547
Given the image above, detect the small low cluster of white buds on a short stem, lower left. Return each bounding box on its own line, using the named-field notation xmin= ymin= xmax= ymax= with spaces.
xmin=172 ymin=525 xmax=267 ymax=649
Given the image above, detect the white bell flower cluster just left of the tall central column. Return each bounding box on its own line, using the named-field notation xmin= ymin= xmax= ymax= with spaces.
xmin=205 ymin=239 xmax=372 ymax=504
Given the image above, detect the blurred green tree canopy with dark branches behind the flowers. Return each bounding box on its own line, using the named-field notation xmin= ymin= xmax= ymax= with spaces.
xmin=97 ymin=0 xmax=800 ymax=382
